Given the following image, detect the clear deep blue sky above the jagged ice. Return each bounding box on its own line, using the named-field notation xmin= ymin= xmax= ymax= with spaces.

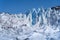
xmin=0 ymin=0 xmax=60 ymax=13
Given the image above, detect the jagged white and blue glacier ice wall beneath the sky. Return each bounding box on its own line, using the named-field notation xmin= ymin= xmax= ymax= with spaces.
xmin=0 ymin=8 xmax=60 ymax=40
